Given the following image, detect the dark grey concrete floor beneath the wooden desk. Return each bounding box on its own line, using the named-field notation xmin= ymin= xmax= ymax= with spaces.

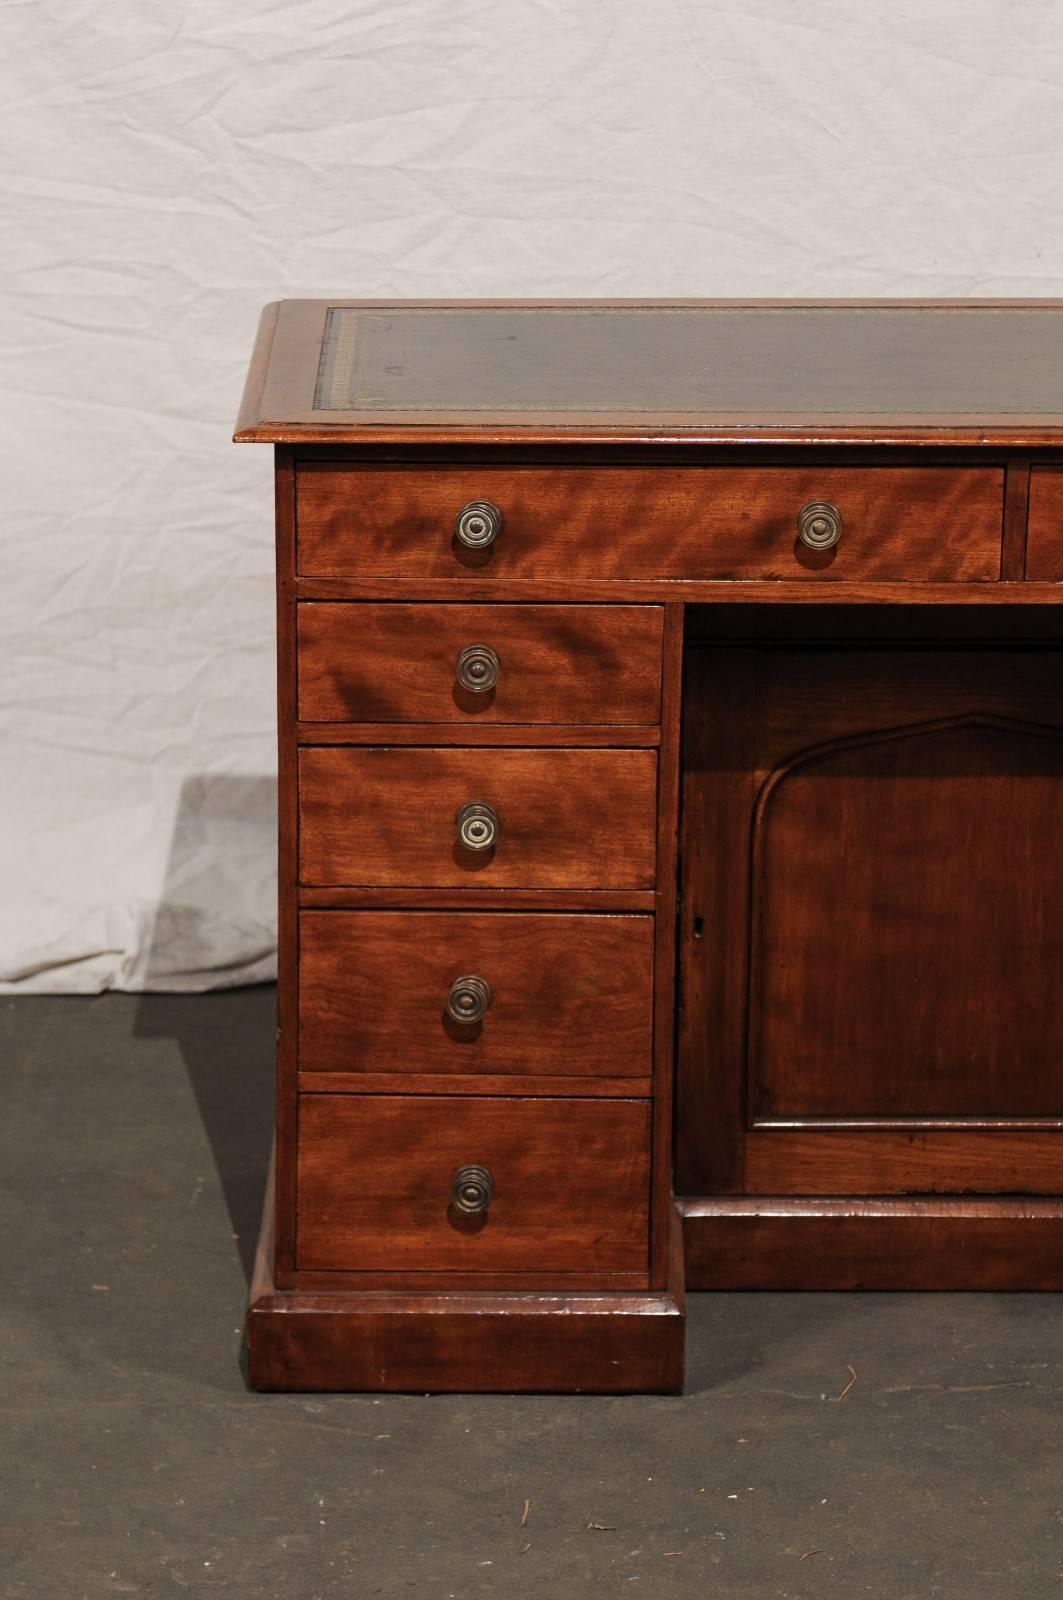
xmin=0 ymin=989 xmax=1063 ymax=1600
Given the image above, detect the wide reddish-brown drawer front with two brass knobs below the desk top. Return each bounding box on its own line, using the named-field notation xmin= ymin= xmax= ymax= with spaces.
xmin=296 ymin=461 xmax=1004 ymax=582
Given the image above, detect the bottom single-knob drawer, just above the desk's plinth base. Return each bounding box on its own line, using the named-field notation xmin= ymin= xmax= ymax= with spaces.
xmin=296 ymin=1094 xmax=650 ymax=1274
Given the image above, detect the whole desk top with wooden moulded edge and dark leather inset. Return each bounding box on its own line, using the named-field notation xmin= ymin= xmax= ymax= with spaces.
xmin=235 ymin=299 xmax=1063 ymax=446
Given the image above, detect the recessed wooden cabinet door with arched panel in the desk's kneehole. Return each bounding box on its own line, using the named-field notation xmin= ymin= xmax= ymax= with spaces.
xmin=677 ymin=645 xmax=1063 ymax=1195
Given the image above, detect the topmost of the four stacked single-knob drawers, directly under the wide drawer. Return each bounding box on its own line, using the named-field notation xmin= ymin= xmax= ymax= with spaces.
xmin=298 ymin=602 xmax=663 ymax=723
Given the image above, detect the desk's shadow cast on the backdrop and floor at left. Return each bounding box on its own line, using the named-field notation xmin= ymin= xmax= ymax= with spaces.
xmin=133 ymin=774 xmax=277 ymax=1283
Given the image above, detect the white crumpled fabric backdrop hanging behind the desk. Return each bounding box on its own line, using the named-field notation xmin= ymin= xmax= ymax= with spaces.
xmin=0 ymin=0 xmax=1063 ymax=990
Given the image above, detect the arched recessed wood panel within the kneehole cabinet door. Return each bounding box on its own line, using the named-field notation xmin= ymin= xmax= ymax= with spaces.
xmin=749 ymin=717 xmax=1063 ymax=1122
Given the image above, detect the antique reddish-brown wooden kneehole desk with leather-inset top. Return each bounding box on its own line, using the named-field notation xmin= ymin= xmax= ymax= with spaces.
xmin=235 ymin=301 xmax=1063 ymax=1390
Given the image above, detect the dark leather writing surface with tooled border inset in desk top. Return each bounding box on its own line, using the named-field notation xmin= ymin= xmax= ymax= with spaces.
xmin=314 ymin=304 xmax=1063 ymax=418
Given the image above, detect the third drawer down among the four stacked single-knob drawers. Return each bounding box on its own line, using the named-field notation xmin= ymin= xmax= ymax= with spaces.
xmin=299 ymin=910 xmax=653 ymax=1077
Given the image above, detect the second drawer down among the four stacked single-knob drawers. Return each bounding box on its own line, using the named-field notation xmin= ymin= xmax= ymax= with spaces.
xmin=299 ymin=747 xmax=656 ymax=890
